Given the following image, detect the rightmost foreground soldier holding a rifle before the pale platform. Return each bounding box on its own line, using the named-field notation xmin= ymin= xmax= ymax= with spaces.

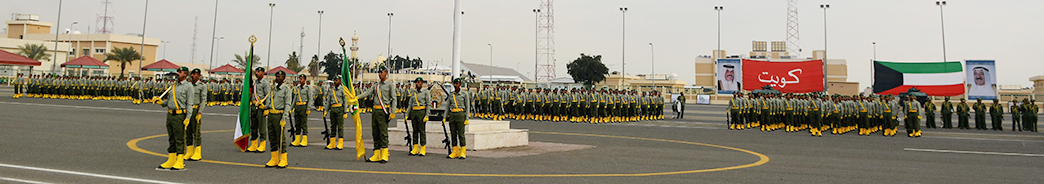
xmin=443 ymin=78 xmax=471 ymax=159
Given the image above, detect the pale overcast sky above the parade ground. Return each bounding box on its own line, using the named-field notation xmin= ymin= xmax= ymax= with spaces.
xmin=8 ymin=0 xmax=1044 ymax=89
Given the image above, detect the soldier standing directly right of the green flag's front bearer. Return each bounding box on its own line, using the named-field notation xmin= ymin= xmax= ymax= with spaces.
xmin=290 ymin=74 xmax=315 ymax=147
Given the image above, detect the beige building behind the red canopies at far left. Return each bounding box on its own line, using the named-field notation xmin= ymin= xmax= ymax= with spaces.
xmin=0 ymin=15 xmax=161 ymax=75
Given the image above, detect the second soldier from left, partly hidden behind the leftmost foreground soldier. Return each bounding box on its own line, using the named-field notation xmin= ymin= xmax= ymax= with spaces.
xmin=185 ymin=68 xmax=208 ymax=161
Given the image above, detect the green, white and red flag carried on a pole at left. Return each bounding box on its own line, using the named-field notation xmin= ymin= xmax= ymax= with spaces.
xmin=232 ymin=36 xmax=257 ymax=152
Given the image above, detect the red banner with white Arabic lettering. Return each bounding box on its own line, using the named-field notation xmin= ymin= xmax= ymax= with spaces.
xmin=743 ymin=60 xmax=824 ymax=93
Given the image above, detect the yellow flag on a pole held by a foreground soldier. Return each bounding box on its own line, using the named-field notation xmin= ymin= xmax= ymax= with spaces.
xmin=339 ymin=38 xmax=366 ymax=160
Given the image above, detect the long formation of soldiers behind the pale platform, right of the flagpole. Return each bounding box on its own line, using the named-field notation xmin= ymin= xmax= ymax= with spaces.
xmin=453 ymin=85 xmax=664 ymax=123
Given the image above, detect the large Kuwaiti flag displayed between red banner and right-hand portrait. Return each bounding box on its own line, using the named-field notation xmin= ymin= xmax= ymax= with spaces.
xmin=874 ymin=61 xmax=965 ymax=96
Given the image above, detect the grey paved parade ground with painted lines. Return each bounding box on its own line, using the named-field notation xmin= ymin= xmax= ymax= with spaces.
xmin=0 ymin=90 xmax=1044 ymax=183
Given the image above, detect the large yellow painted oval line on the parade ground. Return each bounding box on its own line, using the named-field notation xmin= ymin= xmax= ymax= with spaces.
xmin=127 ymin=130 xmax=769 ymax=178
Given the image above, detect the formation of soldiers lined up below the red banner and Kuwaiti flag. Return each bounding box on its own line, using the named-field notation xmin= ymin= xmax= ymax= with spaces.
xmin=727 ymin=93 xmax=1038 ymax=137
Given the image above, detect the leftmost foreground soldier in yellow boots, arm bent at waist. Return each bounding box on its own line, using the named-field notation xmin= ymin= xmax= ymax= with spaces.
xmin=153 ymin=67 xmax=195 ymax=170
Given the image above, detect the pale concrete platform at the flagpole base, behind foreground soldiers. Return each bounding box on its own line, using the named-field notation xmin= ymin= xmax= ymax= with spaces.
xmin=388 ymin=119 xmax=529 ymax=151
